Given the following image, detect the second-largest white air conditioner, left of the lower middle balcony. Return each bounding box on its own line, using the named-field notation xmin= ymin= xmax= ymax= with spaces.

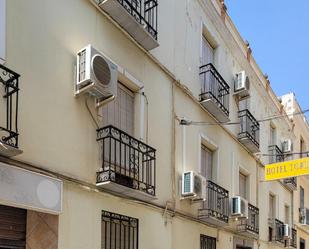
xmin=181 ymin=171 xmax=207 ymax=200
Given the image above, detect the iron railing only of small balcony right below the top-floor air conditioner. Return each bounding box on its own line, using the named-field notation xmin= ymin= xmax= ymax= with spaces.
xmin=238 ymin=109 xmax=260 ymax=148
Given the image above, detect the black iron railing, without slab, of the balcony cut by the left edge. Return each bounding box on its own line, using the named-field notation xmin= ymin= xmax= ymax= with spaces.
xmin=0 ymin=65 xmax=20 ymax=148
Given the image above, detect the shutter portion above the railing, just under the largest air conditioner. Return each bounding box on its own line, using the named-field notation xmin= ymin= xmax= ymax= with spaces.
xmin=103 ymin=83 xmax=134 ymax=136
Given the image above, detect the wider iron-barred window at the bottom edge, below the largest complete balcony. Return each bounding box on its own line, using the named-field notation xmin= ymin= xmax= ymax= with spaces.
xmin=101 ymin=211 xmax=138 ymax=249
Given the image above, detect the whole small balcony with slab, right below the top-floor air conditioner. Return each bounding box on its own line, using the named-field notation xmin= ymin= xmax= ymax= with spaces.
xmin=238 ymin=109 xmax=260 ymax=153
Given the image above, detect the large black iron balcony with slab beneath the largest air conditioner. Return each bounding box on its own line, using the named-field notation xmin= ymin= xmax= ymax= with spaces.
xmin=96 ymin=126 xmax=156 ymax=200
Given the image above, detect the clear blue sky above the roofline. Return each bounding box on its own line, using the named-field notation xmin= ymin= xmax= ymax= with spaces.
xmin=225 ymin=0 xmax=309 ymax=111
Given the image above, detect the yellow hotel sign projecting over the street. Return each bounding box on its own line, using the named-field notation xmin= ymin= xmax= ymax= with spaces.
xmin=265 ymin=157 xmax=309 ymax=181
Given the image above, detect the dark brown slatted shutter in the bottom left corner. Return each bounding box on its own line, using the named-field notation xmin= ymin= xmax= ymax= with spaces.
xmin=0 ymin=205 xmax=27 ymax=249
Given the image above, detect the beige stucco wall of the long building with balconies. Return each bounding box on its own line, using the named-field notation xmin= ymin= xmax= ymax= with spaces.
xmin=1 ymin=0 xmax=306 ymax=249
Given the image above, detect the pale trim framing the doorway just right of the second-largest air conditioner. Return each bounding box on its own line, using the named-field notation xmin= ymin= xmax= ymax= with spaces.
xmin=198 ymin=133 xmax=220 ymax=182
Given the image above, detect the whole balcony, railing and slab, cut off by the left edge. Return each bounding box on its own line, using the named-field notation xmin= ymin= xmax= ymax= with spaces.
xmin=0 ymin=64 xmax=22 ymax=157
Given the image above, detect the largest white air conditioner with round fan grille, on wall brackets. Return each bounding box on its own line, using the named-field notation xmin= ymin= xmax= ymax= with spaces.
xmin=75 ymin=45 xmax=118 ymax=102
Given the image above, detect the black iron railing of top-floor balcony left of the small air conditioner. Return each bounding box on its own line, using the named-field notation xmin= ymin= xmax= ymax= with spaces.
xmin=200 ymin=63 xmax=230 ymax=116
